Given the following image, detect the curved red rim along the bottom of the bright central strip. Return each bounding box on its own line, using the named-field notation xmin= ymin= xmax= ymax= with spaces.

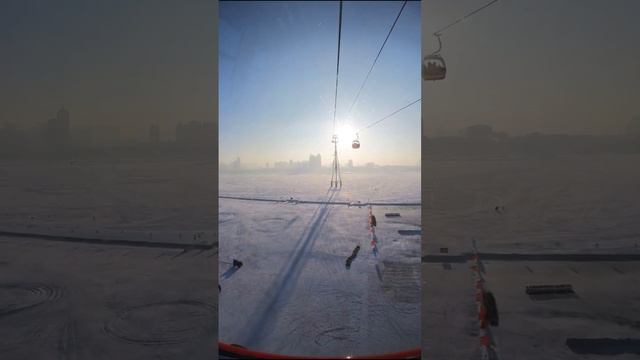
xmin=218 ymin=341 xmax=421 ymax=360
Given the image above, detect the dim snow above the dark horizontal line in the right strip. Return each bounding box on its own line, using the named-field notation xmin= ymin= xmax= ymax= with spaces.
xmin=423 ymin=154 xmax=640 ymax=254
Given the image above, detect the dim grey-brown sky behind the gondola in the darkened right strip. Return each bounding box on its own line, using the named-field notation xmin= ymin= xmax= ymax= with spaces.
xmin=422 ymin=0 xmax=640 ymax=135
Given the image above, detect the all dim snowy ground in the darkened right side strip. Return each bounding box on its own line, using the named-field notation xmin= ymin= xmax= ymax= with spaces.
xmin=422 ymin=154 xmax=640 ymax=360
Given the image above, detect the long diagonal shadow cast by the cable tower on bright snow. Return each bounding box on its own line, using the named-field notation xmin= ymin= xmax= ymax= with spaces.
xmin=239 ymin=190 xmax=339 ymax=347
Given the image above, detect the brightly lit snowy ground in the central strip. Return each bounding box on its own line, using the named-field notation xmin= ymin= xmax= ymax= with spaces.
xmin=219 ymin=169 xmax=421 ymax=355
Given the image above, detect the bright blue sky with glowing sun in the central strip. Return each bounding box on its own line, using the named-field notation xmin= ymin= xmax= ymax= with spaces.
xmin=219 ymin=1 xmax=421 ymax=166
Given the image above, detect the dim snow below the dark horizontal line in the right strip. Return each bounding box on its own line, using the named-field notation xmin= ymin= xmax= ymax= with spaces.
xmin=422 ymin=261 xmax=640 ymax=360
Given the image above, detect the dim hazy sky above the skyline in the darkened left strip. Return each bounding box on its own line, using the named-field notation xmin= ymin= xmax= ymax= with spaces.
xmin=0 ymin=0 xmax=217 ymax=140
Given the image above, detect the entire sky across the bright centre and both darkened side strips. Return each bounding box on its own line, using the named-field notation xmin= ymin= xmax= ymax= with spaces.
xmin=0 ymin=0 xmax=640 ymax=148
